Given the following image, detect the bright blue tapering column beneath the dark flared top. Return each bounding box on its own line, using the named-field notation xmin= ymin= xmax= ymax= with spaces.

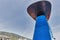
xmin=33 ymin=15 xmax=51 ymax=40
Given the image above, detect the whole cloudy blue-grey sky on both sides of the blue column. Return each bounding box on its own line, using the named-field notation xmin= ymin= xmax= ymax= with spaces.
xmin=0 ymin=0 xmax=60 ymax=40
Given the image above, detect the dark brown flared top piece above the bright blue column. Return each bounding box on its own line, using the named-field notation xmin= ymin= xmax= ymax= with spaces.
xmin=27 ymin=1 xmax=51 ymax=20
